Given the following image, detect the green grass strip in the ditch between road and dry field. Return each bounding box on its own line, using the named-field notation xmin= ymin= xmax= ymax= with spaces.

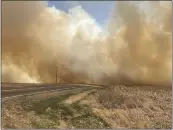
xmin=23 ymin=89 xmax=109 ymax=128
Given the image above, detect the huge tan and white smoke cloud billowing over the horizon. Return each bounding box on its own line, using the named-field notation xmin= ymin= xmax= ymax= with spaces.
xmin=2 ymin=1 xmax=172 ymax=85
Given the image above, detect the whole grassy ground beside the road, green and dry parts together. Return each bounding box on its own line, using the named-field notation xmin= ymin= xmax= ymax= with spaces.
xmin=2 ymin=86 xmax=172 ymax=129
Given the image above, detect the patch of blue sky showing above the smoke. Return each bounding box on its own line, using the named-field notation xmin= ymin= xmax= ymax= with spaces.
xmin=48 ymin=1 xmax=115 ymax=26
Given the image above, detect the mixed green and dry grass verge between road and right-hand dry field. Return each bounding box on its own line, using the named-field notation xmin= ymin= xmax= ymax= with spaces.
xmin=2 ymin=88 xmax=109 ymax=129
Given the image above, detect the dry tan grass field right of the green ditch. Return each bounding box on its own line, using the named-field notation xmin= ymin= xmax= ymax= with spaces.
xmin=80 ymin=86 xmax=172 ymax=128
